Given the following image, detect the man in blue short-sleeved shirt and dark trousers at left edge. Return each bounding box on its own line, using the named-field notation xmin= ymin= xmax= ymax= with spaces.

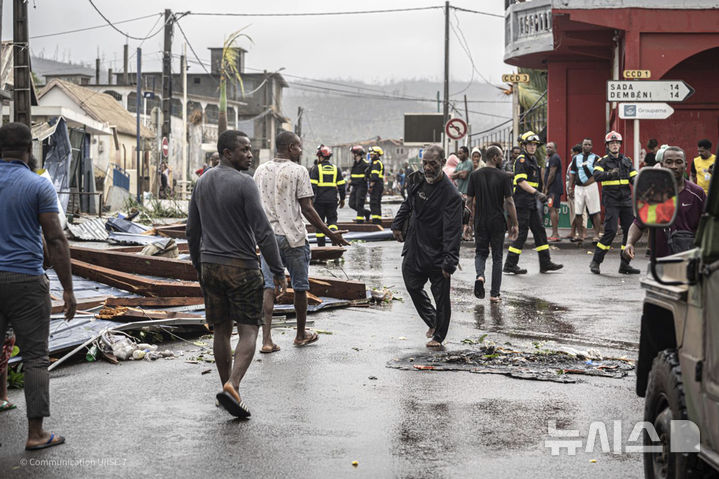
xmin=0 ymin=123 xmax=76 ymax=451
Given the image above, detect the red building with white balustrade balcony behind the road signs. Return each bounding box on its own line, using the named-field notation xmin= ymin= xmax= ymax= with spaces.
xmin=505 ymin=0 xmax=719 ymax=172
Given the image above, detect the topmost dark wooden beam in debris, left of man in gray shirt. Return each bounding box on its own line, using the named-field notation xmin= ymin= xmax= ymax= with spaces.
xmin=70 ymin=246 xmax=198 ymax=282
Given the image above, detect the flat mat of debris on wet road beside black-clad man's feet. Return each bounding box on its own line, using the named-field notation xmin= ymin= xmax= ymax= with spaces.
xmin=387 ymin=344 xmax=634 ymax=383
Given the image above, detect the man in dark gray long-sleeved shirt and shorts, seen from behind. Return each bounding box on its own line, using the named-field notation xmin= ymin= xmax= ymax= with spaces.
xmin=187 ymin=130 xmax=287 ymax=418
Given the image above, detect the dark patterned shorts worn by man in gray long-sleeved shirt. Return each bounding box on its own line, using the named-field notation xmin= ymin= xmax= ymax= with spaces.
xmin=202 ymin=263 xmax=264 ymax=326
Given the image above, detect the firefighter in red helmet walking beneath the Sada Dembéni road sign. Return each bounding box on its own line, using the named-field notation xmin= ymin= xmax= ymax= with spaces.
xmin=589 ymin=131 xmax=640 ymax=274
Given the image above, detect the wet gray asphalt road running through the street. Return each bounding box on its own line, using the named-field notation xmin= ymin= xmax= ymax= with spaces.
xmin=0 ymin=210 xmax=646 ymax=478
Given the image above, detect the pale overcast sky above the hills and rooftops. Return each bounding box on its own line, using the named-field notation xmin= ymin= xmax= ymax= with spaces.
xmin=9 ymin=0 xmax=511 ymax=84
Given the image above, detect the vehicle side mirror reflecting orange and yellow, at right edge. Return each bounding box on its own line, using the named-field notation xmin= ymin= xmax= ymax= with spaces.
xmin=634 ymin=168 xmax=679 ymax=228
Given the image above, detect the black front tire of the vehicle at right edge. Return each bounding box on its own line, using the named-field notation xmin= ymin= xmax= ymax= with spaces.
xmin=643 ymin=349 xmax=698 ymax=479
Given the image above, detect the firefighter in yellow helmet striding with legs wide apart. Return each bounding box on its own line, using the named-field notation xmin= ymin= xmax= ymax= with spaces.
xmin=503 ymin=131 xmax=563 ymax=274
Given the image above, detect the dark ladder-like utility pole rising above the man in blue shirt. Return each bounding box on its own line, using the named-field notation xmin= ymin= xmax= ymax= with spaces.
xmin=12 ymin=0 xmax=32 ymax=128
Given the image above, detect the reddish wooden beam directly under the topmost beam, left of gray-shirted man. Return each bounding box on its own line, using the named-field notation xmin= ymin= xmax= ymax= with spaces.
xmin=71 ymin=259 xmax=202 ymax=297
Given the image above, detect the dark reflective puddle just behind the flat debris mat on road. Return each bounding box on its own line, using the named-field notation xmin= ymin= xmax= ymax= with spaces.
xmin=474 ymin=295 xmax=575 ymax=334
